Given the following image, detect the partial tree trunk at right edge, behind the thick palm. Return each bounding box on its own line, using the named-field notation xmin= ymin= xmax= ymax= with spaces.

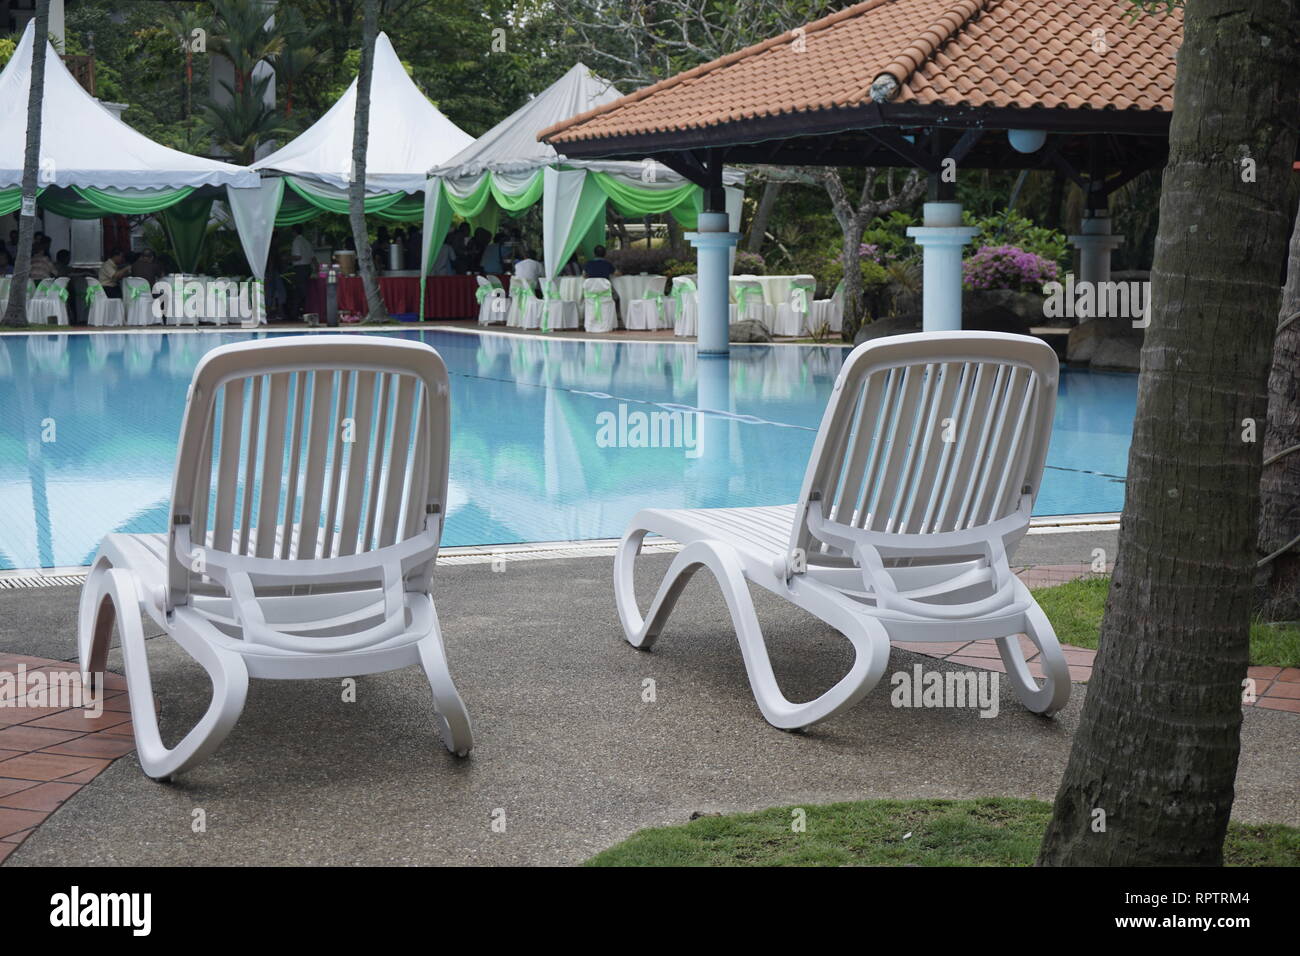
xmin=1256 ymin=204 xmax=1300 ymax=620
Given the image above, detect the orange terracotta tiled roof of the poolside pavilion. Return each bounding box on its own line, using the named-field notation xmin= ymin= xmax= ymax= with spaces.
xmin=538 ymin=0 xmax=1183 ymax=146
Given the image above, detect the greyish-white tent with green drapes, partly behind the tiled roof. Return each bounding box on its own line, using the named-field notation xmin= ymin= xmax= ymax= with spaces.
xmin=421 ymin=64 xmax=745 ymax=283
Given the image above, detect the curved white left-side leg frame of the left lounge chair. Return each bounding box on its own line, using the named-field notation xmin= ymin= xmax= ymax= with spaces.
xmin=78 ymin=566 xmax=248 ymax=780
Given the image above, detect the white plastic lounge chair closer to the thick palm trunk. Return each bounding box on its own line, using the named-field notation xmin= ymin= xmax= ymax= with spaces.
xmin=614 ymin=332 xmax=1070 ymax=730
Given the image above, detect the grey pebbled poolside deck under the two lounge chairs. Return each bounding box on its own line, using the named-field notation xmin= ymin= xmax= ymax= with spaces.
xmin=0 ymin=532 xmax=1300 ymax=865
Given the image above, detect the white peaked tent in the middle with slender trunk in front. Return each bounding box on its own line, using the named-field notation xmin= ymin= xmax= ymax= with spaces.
xmin=233 ymin=33 xmax=473 ymax=280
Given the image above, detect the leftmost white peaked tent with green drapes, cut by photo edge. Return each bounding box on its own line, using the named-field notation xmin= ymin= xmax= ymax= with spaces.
xmin=0 ymin=21 xmax=257 ymax=269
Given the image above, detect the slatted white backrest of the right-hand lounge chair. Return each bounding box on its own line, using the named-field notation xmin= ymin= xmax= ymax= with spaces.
xmin=790 ymin=332 xmax=1060 ymax=563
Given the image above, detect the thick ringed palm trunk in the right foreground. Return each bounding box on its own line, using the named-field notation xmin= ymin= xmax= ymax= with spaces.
xmin=1039 ymin=0 xmax=1300 ymax=866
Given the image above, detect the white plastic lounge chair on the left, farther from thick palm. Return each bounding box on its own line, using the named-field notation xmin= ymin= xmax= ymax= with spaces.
xmin=78 ymin=336 xmax=473 ymax=779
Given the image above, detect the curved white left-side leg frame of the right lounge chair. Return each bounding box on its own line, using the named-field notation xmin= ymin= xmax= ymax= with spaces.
xmin=614 ymin=529 xmax=889 ymax=730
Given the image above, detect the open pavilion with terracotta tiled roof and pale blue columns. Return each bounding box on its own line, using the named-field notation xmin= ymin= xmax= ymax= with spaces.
xmin=541 ymin=0 xmax=1182 ymax=352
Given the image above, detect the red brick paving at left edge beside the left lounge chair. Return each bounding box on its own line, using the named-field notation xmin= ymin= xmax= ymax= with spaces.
xmin=0 ymin=654 xmax=135 ymax=864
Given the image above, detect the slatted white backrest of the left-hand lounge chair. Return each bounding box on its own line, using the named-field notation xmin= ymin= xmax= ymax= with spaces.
xmin=168 ymin=336 xmax=450 ymax=607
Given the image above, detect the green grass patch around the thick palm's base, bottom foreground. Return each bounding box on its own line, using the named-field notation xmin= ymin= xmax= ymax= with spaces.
xmin=586 ymin=797 xmax=1300 ymax=866
